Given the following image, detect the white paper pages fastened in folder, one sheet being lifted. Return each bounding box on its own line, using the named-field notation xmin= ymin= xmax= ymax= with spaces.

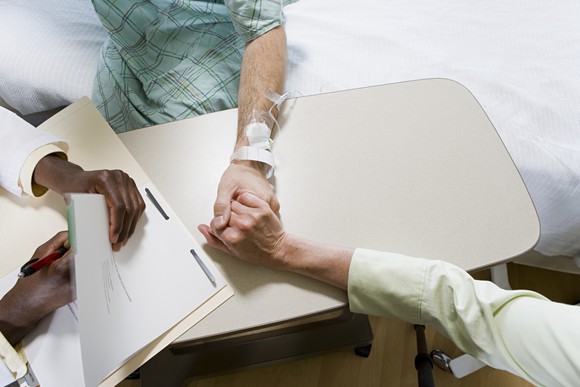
xmin=69 ymin=184 xmax=226 ymax=386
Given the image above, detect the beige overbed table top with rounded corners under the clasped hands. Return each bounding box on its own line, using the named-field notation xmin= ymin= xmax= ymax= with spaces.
xmin=120 ymin=79 xmax=539 ymax=340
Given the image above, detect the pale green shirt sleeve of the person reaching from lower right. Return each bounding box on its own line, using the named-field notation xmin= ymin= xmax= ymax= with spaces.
xmin=348 ymin=249 xmax=580 ymax=386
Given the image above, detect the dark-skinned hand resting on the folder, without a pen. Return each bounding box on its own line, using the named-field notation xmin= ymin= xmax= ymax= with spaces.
xmin=34 ymin=155 xmax=145 ymax=251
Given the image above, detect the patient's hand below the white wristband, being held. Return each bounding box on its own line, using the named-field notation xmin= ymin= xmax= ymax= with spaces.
xmin=211 ymin=160 xmax=280 ymax=236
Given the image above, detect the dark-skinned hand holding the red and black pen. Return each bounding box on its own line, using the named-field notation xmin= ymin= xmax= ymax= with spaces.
xmin=0 ymin=231 xmax=73 ymax=345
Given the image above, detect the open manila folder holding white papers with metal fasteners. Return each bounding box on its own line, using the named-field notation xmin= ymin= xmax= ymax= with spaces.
xmin=0 ymin=98 xmax=233 ymax=387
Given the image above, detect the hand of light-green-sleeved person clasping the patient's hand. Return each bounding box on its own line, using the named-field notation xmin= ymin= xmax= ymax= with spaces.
xmin=198 ymin=192 xmax=289 ymax=269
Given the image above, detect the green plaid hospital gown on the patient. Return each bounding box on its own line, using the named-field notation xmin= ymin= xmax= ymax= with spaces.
xmin=92 ymin=0 xmax=296 ymax=132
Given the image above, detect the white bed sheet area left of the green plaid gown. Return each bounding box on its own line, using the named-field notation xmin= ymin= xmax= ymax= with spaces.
xmin=0 ymin=0 xmax=107 ymax=114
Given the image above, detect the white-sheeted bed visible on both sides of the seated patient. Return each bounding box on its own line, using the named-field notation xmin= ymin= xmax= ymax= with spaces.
xmin=0 ymin=0 xmax=580 ymax=257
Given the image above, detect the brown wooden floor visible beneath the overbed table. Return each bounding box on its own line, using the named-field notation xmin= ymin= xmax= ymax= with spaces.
xmin=121 ymin=264 xmax=580 ymax=387
